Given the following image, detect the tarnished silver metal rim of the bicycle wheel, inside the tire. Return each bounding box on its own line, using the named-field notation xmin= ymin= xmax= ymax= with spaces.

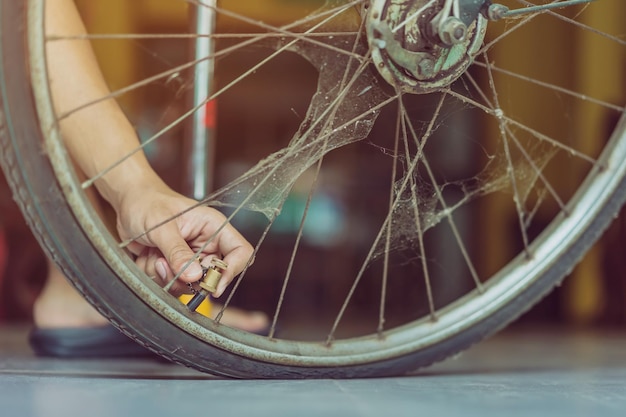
xmin=28 ymin=0 xmax=626 ymax=367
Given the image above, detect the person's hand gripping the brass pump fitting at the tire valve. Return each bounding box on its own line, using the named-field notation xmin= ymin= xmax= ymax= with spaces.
xmin=116 ymin=184 xmax=253 ymax=297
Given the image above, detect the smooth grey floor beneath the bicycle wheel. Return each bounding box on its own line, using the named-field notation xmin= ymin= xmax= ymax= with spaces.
xmin=0 ymin=327 xmax=626 ymax=417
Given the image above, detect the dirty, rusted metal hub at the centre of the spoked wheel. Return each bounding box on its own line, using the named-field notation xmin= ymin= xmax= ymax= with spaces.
xmin=367 ymin=0 xmax=491 ymax=94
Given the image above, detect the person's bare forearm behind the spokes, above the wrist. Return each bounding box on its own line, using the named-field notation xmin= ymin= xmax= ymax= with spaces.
xmin=46 ymin=0 xmax=165 ymax=209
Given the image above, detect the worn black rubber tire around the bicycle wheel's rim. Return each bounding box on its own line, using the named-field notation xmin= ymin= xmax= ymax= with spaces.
xmin=0 ymin=0 xmax=626 ymax=378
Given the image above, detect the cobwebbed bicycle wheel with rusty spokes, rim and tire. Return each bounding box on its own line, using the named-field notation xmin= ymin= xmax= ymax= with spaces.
xmin=0 ymin=0 xmax=626 ymax=378
